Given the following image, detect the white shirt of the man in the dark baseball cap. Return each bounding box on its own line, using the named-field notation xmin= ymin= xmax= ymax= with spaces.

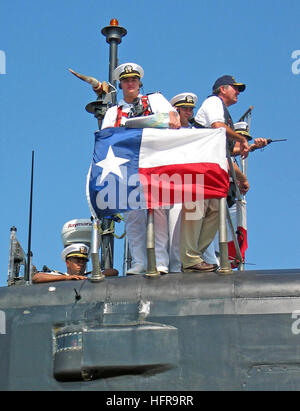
xmin=195 ymin=96 xmax=225 ymax=128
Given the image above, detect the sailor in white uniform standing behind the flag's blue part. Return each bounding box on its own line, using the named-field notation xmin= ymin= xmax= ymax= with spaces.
xmin=101 ymin=63 xmax=180 ymax=274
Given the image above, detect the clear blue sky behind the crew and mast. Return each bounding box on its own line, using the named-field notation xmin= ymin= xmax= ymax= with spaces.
xmin=0 ymin=0 xmax=300 ymax=285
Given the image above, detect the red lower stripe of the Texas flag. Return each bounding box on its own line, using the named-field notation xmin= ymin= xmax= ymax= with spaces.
xmin=139 ymin=163 xmax=229 ymax=208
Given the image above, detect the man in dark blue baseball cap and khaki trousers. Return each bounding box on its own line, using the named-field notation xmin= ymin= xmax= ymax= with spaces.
xmin=180 ymin=75 xmax=249 ymax=272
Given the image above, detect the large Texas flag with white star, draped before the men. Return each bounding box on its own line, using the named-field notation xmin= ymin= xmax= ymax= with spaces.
xmin=87 ymin=127 xmax=229 ymax=218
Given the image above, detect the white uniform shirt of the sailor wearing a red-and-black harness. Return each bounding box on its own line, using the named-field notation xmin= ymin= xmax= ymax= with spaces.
xmin=101 ymin=92 xmax=176 ymax=129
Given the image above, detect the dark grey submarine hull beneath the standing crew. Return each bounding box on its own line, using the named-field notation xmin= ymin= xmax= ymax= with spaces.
xmin=0 ymin=269 xmax=300 ymax=391
